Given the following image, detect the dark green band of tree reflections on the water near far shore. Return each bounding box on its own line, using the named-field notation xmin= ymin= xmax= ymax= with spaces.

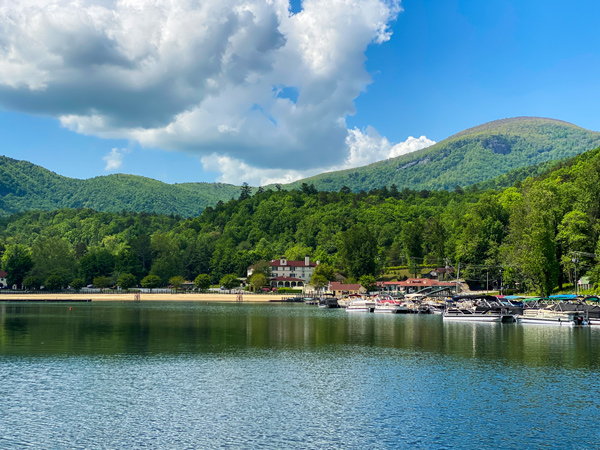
xmin=0 ymin=303 xmax=600 ymax=367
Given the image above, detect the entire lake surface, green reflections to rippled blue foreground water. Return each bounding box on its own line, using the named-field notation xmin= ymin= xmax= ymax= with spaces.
xmin=0 ymin=302 xmax=600 ymax=449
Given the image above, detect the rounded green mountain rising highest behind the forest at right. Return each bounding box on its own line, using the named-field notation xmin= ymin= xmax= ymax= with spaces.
xmin=288 ymin=117 xmax=600 ymax=192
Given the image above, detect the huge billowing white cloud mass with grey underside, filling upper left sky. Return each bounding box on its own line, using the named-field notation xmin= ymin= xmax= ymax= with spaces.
xmin=0 ymin=0 xmax=421 ymax=178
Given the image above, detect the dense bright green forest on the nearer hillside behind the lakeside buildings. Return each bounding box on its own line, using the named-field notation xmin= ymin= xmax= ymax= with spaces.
xmin=0 ymin=144 xmax=600 ymax=294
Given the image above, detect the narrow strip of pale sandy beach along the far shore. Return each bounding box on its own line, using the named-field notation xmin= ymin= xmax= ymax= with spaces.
xmin=0 ymin=293 xmax=293 ymax=303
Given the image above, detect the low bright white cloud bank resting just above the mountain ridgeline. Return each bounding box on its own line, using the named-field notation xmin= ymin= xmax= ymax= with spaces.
xmin=202 ymin=127 xmax=435 ymax=186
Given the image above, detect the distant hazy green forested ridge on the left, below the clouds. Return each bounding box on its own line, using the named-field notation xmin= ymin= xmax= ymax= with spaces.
xmin=0 ymin=156 xmax=240 ymax=217
